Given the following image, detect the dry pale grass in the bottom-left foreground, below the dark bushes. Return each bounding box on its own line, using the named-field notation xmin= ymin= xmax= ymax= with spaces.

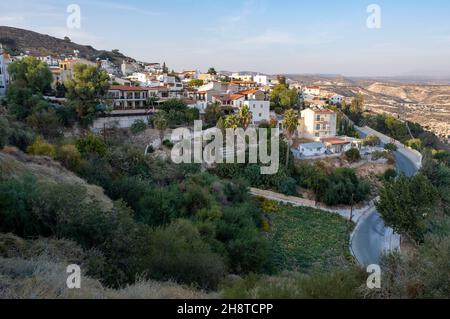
xmin=0 ymin=234 xmax=216 ymax=299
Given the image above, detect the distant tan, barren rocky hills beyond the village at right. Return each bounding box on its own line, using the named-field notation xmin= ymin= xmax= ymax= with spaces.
xmin=287 ymin=75 xmax=450 ymax=142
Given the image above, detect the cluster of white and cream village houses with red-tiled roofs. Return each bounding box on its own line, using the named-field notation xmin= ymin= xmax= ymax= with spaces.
xmin=0 ymin=44 xmax=366 ymax=157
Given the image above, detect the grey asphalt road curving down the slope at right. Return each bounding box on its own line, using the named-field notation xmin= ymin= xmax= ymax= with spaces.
xmin=351 ymin=131 xmax=417 ymax=266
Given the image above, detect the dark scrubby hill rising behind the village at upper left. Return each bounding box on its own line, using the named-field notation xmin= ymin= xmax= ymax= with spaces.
xmin=0 ymin=26 xmax=133 ymax=65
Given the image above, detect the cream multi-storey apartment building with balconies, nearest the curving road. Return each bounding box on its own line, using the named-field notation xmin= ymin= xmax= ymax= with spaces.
xmin=298 ymin=107 xmax=337 ymax=141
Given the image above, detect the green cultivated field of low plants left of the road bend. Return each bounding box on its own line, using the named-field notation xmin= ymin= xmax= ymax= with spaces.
xmin=269 ymin=205 xmax=354 ymax=272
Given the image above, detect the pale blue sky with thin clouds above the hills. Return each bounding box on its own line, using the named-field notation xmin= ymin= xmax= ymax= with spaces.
xmin=0 ymin=0 xmax=450 ymax=76
